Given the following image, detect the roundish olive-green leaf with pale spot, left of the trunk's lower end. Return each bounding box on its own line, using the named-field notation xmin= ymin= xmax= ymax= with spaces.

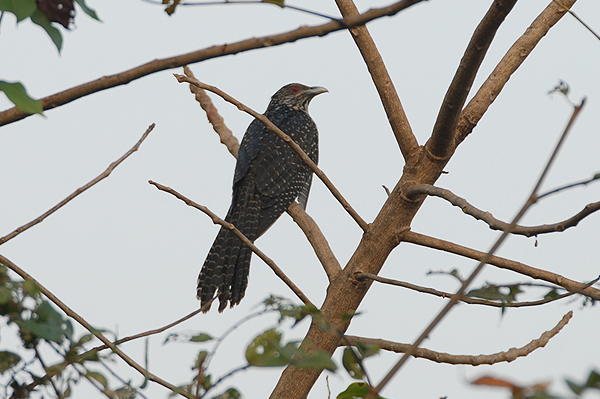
xmin=246 ymin=329 xmax=293 ymax=367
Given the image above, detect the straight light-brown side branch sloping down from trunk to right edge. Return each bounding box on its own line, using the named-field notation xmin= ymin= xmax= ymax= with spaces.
xmin=402 ymin=231 xmax=600 ymax=300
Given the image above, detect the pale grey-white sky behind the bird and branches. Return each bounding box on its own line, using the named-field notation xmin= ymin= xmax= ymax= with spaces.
xmin=0 ymin=0 xmax=600 ymax=399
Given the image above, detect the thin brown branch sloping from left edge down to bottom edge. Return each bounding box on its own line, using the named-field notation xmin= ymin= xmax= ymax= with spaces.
xmin=0 ymin=255 xmax=194 ymax=399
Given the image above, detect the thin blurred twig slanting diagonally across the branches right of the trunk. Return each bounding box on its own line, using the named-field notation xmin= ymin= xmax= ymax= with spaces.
xmin=374 ymin=98 xmax=585 ymax=393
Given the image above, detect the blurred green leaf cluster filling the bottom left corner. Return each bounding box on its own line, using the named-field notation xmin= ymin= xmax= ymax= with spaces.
xmin=0 ymin=265 xmax=135 ymax=399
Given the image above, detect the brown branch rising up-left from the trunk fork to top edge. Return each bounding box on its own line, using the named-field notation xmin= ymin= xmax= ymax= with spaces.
xmin=336 ymin=0 xmax=419 ymax=164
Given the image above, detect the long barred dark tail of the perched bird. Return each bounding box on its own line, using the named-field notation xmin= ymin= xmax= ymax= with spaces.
xmin=196 ymin=183 xmax=259 ymax=312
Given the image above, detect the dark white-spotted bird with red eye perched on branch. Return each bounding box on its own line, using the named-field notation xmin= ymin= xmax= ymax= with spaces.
xmin=196 ymin=83 xmax=327 ymax=312
